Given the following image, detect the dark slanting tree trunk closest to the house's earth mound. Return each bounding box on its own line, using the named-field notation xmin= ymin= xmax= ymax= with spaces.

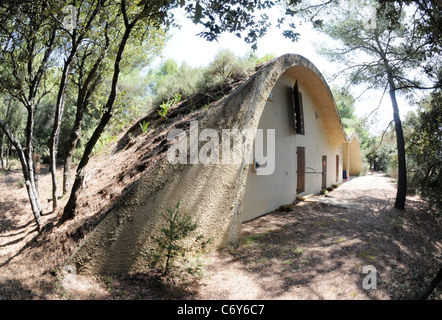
xmin=61 ymin=21 xmax=136 ymax=222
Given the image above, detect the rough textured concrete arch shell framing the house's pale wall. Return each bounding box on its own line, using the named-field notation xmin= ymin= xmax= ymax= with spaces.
xmin=67 ymin=54 xmax=356 ymax=274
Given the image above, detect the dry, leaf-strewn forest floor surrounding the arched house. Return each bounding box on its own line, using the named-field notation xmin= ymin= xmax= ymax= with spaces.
xmin=0 ymin=162 xmax=442 ymax=300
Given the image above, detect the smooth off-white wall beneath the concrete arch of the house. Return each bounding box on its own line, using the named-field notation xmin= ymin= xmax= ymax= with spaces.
xmin=242 ymin=72 xmax=343 ymax=221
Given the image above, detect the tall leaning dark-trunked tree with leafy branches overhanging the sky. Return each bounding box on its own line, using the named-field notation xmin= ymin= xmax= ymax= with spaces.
xmin=57 ymin=0 xmax=308 ymax=222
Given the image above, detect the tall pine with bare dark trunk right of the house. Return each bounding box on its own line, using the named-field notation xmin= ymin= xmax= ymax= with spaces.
xmin=316 ymin=1 xmax=440 ymax=210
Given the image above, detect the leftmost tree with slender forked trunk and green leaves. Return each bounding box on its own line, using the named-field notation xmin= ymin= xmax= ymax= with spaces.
xmin=0 ymin=0 xmax=57 ymax=230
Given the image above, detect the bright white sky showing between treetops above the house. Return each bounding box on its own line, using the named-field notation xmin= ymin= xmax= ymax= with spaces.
xmin=151 ymin=5 xmax=414 ymax=133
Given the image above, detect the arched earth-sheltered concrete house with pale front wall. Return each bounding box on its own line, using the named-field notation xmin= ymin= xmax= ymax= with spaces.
xmin=67 ymin=54 xmax=361 ymax=274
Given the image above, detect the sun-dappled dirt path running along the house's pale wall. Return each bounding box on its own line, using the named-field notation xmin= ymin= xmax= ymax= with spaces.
xmin=196 ymin=174 xmax=442 ymax=299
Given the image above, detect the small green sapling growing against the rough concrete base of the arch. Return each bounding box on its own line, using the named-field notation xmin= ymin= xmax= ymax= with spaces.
xmin=150 ymin=202 xmax=210 ymax=280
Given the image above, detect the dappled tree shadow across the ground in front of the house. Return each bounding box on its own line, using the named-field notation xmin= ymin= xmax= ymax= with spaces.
xmin=209 ymin=192 xmax=442 ymax=299
